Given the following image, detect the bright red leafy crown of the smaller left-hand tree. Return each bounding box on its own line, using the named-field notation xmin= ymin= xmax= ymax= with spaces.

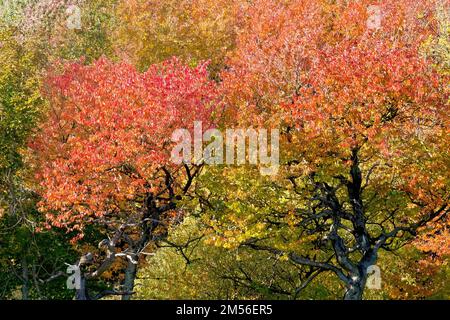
xmin=33 ymin=58 xmax=217 ymax=238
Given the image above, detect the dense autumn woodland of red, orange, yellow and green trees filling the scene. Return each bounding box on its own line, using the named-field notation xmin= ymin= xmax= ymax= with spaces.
xmin=0 ymin=0 xmax=450 ymax=299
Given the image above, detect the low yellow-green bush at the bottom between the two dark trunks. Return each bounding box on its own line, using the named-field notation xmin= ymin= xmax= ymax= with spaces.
xmin=136 ymin=215 xmax=342 ymax=300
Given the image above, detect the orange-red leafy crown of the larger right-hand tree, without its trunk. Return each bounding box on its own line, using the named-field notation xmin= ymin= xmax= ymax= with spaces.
xmin=222 ymin=0 xmax=449 ymax=255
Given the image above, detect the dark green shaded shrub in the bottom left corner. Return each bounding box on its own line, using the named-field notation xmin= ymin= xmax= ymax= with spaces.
xmin=0 ymin=202 xmax=78 ymax=300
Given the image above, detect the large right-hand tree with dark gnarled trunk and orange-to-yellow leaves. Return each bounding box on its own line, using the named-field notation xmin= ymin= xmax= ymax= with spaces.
xmin=201 ymin=0 xmax=449 ymax=299
